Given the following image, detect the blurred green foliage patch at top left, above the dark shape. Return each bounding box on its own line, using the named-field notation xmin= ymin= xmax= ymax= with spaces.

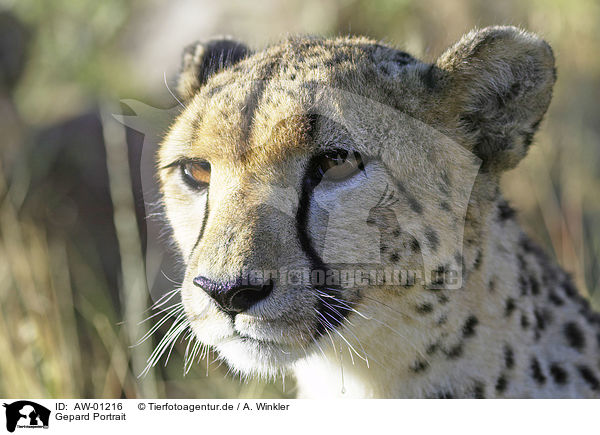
xmin=11 ymin=0 xmax=136 ymax=123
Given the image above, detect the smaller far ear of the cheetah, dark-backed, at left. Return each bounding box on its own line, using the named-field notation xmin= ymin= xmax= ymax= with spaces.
xmin=177 ymin=38 xmax=250 ymax=101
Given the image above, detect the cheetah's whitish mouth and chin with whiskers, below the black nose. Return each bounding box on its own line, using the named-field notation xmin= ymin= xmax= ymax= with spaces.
xmin=186 ymin=280 xmax=354 ymax=375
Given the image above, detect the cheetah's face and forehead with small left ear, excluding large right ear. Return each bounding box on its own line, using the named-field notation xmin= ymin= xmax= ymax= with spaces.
xmin=158 ymin=31 xmax=556 ymax=375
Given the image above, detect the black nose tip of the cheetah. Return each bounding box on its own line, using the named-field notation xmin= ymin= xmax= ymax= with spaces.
xmin=194 ymin=276 xmax=273 ymax=315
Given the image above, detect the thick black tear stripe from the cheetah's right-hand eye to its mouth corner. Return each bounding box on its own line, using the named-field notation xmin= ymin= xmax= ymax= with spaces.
xmin=296 ymin=157 xmax=353 ymax=338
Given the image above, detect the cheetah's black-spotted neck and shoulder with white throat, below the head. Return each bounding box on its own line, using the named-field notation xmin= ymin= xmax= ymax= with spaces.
xmin=295 ymin=199 xmax=600 ymax=398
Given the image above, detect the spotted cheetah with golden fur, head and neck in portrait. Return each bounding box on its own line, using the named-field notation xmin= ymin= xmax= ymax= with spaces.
xmin=157 ymin=26 xmax=600 ymax=398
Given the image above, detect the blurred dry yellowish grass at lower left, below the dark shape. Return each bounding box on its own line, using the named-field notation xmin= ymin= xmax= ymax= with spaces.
xmin=0 ymin=157 xmax=290 ymax=398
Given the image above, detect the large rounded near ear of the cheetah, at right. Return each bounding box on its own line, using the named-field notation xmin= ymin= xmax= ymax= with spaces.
xmin=435 ymin=26 xmax=556 ymax=170
